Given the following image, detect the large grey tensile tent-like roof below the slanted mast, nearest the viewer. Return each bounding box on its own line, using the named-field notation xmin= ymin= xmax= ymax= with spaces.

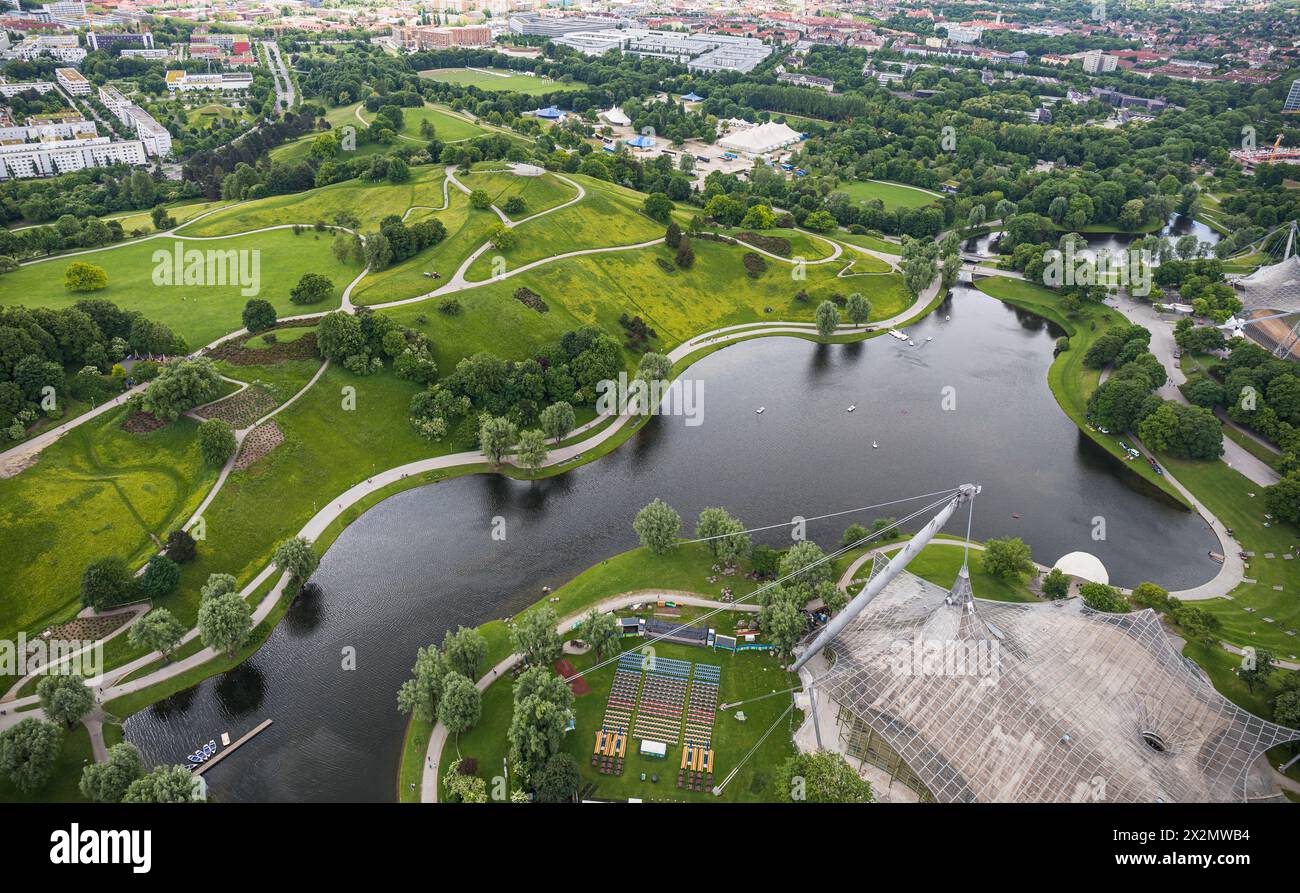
xmin=796 ymin=567 xmax=1300 ymax=803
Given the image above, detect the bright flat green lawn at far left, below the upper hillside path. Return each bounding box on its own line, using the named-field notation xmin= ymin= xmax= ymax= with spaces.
xmin=0 ymin=230 xmax=358 ymax=348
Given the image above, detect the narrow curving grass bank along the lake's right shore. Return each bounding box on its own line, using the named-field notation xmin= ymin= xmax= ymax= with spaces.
xmin=975 ymin=276 xmax=1187 ymax=506
